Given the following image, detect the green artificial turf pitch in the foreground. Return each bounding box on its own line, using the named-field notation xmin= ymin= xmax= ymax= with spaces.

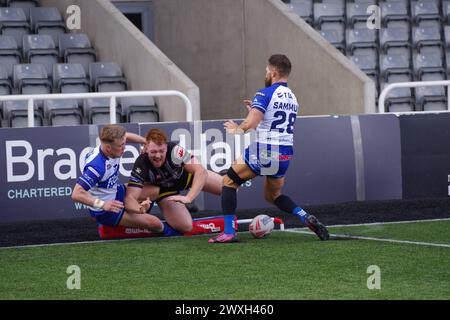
xmin=0 ymin=221 xmax=450 ymax=300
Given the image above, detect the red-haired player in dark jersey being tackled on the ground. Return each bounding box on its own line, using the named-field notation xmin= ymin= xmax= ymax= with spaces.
xmin=125 ymin=129 xmax=222 ymax=235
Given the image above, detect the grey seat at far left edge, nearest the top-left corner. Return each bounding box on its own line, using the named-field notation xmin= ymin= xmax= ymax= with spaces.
xmin=0 ymin=8 xmax=30 ymax=48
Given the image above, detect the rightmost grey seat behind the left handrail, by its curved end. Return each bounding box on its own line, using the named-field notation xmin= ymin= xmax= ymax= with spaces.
xmin=121 ymin=97 xmax=159 ymax=123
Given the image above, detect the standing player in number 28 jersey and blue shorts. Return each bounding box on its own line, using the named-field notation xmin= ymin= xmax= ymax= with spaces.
xmin=209 ymin=54 xmax=329 ymax=243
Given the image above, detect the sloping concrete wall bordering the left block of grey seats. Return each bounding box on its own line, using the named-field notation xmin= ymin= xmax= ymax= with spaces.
xmin=42 ymin=0 xmax=200 ymax=121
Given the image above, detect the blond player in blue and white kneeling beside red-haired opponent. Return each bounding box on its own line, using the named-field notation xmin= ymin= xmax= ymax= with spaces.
xmin=72 ymin=125 xmax=164 ymax=232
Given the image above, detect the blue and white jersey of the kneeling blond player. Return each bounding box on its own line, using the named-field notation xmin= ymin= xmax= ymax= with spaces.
xmin=77 ymin=146 xmax=120 ymax=211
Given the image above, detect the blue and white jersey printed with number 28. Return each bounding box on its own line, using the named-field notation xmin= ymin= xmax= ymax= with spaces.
xmin=252 ymin=82 xmax=299 ymax=146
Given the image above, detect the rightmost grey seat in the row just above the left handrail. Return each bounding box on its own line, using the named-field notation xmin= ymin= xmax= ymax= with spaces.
xmin=89 ymin=62 xmax=127 ymax=92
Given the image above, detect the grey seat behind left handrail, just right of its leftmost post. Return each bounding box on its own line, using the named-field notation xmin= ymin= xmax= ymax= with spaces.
xmin=44 ymin=99 xmax=83 ymax=126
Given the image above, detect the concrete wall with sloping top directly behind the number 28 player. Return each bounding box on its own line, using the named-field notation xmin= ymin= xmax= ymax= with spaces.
xmin=152 ymin=0 xmax=375 ymax=120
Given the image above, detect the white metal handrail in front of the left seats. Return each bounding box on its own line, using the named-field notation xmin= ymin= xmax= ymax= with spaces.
xmin=0 ymin=90 xmax=193 ymax=127
